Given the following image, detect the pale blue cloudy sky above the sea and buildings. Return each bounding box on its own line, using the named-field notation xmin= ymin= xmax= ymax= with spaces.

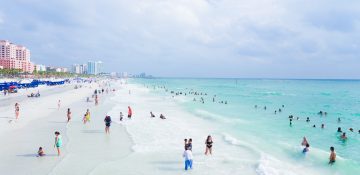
xmin=0 ymin=0 xmax=360 ymax=79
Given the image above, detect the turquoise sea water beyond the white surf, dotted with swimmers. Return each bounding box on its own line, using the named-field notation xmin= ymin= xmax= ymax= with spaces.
xmin=131 ymin=79 xmax=360 ymax=174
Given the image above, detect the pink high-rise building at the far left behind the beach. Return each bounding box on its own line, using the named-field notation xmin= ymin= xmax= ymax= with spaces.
xmin=0 ymin=40 xmax=34 ymax=73
